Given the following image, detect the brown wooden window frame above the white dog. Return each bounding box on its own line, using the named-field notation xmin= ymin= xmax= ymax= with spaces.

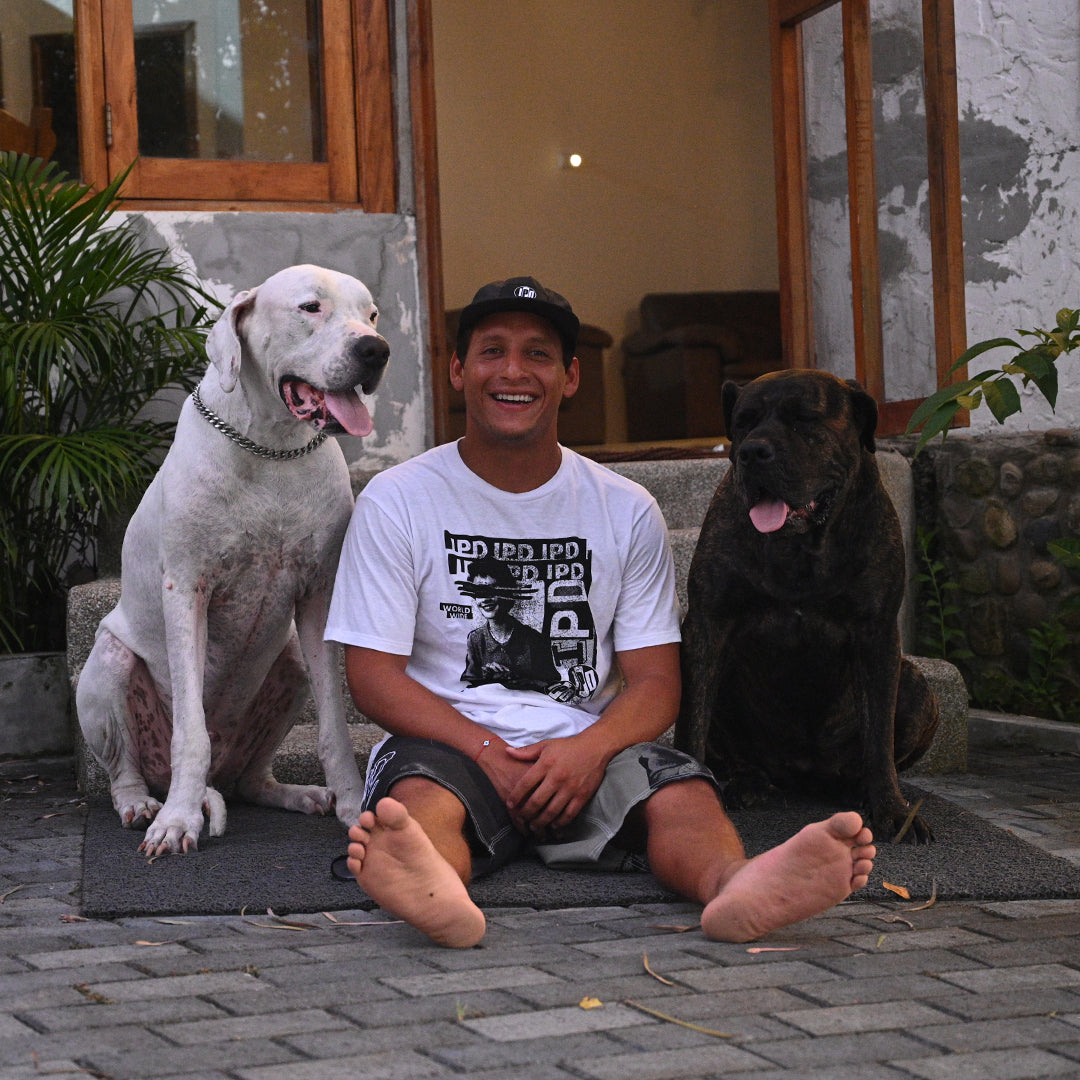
xmin=75 ymin=0 xmax=397 ymax=213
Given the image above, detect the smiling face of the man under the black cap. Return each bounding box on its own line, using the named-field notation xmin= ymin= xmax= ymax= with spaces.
xmin=450 ymin=311 xmax=578 ymax=445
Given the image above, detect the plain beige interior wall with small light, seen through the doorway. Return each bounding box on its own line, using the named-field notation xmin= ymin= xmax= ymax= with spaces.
xmin=432 ymin=0 xmax=778 ymax=441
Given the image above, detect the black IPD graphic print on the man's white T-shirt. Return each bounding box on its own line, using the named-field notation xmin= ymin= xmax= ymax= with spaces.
xmin=441 ymin=532 xmax=598 ymax=703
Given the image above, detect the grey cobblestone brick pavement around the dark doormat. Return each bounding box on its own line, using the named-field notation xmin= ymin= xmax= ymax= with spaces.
xmin=0 ymin=751 xmax=1080 ymax=1080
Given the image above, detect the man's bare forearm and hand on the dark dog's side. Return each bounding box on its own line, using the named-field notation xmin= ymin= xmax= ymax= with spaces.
xmin=505 ymin=643 xmax=681 ymax=832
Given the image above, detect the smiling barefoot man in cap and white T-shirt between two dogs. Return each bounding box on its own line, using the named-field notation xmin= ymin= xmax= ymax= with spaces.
xmin=326 ymin=278 xmax=875 ymax=947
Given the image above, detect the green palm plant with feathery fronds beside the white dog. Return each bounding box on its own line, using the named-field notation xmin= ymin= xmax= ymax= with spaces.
xmin=0 ymin=153 xmax=216 ymax=651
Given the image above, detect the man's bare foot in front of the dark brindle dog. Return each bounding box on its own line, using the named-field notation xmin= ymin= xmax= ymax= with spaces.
xmin=701 ymin=811 xmax=877 ymax=942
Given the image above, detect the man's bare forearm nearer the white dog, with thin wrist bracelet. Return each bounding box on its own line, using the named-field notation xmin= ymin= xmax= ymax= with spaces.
xmin=345 ymin=645 xmax=528 ymax=801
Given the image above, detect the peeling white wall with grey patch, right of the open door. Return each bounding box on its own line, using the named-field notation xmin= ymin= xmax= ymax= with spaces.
xmin=956 ymin=0 xmax=1080 ymax=432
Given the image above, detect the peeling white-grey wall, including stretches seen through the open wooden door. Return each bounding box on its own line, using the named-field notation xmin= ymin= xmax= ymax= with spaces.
xmin=805 ymin=0 xmax=1080 ymax=431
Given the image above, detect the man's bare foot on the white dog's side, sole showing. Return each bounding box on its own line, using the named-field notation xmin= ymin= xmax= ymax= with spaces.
xmin=349 ymin=798 xmax=486 ymax=948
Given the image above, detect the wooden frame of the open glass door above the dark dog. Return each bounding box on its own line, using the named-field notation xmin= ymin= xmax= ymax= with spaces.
xmin=769 ymin=0 xmax=967 ymax=434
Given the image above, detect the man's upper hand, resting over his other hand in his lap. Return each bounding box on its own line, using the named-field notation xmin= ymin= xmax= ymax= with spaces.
xmin=505 ymin=729 xmax=612 ymax=834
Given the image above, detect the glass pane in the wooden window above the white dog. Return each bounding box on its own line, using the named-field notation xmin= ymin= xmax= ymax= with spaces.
xmin=134 ymin=0 xmax=325 ymax=162
